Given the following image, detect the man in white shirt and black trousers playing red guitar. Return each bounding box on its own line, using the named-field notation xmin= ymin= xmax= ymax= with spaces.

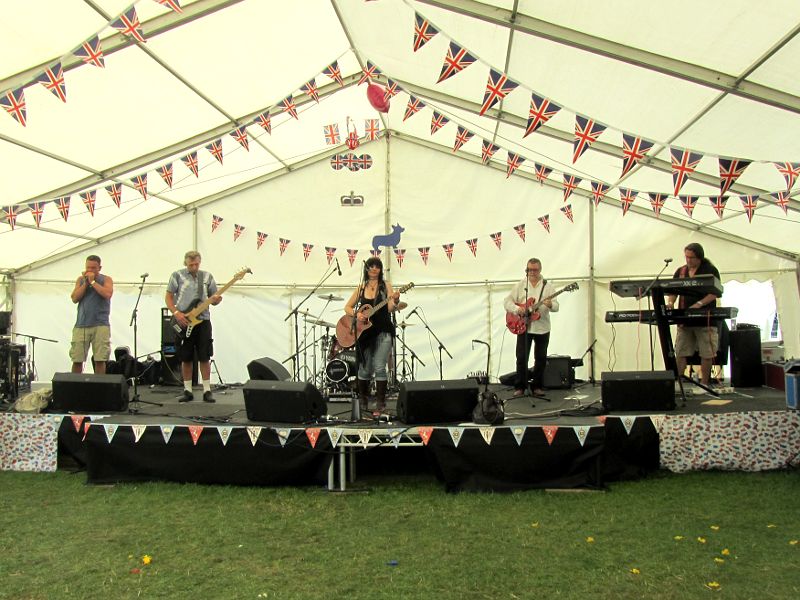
xmin=503 ymin=258 xmax=558 ymax=398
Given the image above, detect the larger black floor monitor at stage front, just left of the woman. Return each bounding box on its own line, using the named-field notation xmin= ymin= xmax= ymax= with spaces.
xmin=243 ymin=380 xmax=327 ymax=423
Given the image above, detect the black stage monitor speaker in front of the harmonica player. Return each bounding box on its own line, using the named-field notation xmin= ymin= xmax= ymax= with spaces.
xmin=52 ymin=373 xmax=128 ymax=413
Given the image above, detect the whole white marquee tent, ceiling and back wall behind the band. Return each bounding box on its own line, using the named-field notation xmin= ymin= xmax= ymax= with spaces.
xmin=0 ymin=0 xmax=800 ymax=381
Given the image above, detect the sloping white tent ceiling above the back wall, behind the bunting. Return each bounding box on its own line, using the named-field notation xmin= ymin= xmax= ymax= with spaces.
xmin=0 ymin=0 xmax=800 ymax=271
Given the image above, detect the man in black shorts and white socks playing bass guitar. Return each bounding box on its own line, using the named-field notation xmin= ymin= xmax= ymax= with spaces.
xmin=165 ymin=250 xmax=222 ymax=402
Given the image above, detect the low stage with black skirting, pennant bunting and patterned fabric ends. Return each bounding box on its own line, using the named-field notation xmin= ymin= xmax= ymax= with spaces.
xmin=0 ymin=382 xmax=800 ymax=492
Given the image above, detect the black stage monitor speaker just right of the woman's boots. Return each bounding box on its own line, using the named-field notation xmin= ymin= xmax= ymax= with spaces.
xmin=397 ymin=379 xmax=479 ymax=425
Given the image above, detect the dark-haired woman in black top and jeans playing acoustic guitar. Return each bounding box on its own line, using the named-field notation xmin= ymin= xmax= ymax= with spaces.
xmin=344 ymin=256 xmax=400 ymax=412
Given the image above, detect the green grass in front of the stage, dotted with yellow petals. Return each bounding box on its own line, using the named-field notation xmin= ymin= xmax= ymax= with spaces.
xmin=0 ymin=472 xmax=800 ymax=599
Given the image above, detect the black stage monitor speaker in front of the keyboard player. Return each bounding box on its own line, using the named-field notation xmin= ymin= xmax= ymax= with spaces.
xmin=600 ymin=371 xmax=675 ymax=411
